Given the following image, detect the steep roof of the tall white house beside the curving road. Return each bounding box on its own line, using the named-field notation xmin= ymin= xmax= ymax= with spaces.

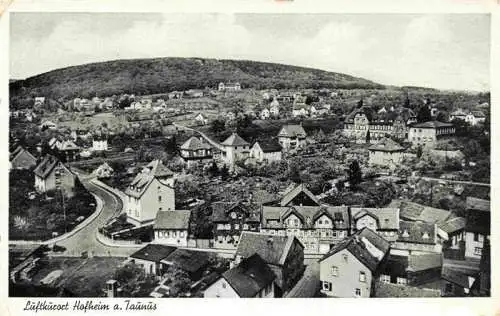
xmin=125 ymin=159 xmax=173 ymax=198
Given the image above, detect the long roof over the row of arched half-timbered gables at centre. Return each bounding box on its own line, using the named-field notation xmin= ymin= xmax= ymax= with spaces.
xmin=261 ymin=205 xmax=349 ymax=229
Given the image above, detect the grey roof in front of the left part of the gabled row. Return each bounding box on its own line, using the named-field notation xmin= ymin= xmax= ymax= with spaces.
xmin=235 ymin=232 xmax=300 ymax=266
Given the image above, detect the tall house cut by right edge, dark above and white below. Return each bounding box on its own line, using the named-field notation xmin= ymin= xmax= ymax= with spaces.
xmin=465 ymin=197 xmax=491 ymax=259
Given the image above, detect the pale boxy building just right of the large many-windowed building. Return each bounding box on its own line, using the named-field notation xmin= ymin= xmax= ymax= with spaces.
xmin=408 ymin=121 xmax=455 ymax=148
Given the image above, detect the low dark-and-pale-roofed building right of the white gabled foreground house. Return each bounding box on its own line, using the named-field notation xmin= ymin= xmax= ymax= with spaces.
xmin=379 ymin=253 xmax=443 ymax=286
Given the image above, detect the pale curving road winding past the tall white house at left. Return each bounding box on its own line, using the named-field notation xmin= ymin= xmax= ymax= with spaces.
xmin=57 ymin=179 xmax=137 ymax=257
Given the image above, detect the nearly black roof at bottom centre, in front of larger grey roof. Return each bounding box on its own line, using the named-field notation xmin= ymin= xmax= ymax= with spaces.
xmin=222 ymin=254 xmax=276 ymax=297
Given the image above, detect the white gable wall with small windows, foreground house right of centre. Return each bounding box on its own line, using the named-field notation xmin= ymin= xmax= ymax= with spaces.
xmin=320 ymin=249 xmax=372 ymax=297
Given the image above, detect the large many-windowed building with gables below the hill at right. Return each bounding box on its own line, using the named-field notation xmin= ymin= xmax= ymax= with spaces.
xmin=344 ymin=106 xmax=417 ymax=144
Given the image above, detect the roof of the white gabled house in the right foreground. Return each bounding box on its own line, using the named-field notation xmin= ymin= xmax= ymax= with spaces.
xmin=320 ymin=227 xmax=390 ymax=271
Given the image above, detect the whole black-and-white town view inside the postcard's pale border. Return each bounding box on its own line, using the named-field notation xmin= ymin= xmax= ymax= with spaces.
xmin=5 ymin=12 xmax=492 ymax=302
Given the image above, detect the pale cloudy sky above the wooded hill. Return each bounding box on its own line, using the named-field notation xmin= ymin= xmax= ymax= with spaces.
xmin=10 ymin=12 xmax=490 ymax=91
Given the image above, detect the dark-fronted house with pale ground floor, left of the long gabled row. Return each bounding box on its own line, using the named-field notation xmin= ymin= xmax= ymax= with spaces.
xmin=211 ymin=201 xmax=260 ymax=249
